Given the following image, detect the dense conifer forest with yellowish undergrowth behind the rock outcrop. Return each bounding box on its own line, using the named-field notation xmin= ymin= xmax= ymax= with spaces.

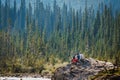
xmin=0 ymin=0 xmax=120 ymax=74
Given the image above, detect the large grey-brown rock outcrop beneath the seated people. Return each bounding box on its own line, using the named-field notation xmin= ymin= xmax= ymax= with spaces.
xmin=52 ymin=58 xmax=114 ymax=80
